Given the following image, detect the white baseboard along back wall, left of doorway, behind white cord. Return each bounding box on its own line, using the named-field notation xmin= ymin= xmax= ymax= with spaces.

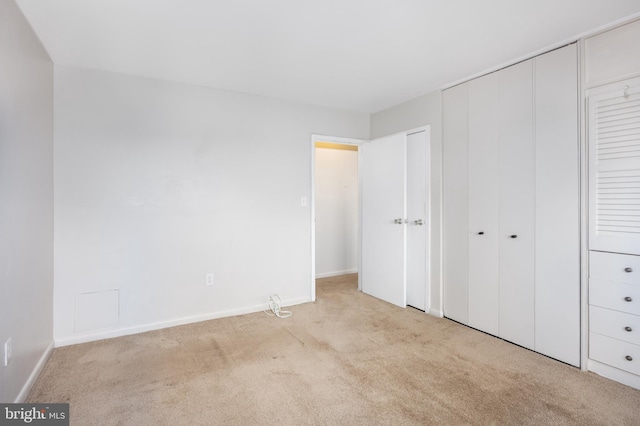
xmin=55 ymin=297 xmax=311 ymax=348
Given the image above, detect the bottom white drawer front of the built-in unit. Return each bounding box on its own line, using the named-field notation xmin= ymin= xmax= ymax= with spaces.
xmin=589 ymin=333 xmax=640 ymax=375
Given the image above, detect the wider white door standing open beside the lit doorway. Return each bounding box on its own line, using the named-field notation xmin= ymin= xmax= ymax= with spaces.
xmin=360 ymin=134 xmax=407 ymax=307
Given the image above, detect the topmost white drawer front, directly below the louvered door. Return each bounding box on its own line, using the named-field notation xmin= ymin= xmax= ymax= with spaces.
xmin=589 ymin=251 xmax=640 ymax=285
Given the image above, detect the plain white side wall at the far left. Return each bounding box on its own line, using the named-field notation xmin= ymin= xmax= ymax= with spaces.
xmin=0 ymin=1 xmax=53 ymax=402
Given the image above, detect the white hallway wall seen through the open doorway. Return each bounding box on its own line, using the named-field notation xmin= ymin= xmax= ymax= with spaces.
xmin=315 ymin=148 xmax=358 ymax=278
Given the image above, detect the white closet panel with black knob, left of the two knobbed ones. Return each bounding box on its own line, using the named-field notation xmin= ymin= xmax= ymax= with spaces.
xmin=468 ymin=73 xmax=500 ymax=335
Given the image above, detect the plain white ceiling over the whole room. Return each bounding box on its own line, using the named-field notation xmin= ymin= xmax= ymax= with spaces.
xmin=16 ymin=0 xmax=640 ymax=112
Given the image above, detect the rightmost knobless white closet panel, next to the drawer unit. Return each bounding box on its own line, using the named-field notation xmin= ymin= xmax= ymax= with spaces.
xmin=535 ymin=45 xmax=580 ymax=366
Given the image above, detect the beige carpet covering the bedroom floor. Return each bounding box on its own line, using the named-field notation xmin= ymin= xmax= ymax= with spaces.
xmin=28 ymin=275 xmax=640 ymax=425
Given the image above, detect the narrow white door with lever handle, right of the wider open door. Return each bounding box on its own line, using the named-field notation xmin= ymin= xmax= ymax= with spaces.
xmin=407 ymin=131 xmax=429 ymax=311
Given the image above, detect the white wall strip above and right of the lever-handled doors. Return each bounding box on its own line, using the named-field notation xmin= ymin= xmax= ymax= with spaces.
xmin=371 ymin=91 xmax=442 ymax=315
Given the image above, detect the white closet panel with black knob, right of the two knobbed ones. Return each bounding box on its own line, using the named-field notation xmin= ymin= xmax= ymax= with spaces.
xmin=498 ymin=60 xmax=535 ymax=349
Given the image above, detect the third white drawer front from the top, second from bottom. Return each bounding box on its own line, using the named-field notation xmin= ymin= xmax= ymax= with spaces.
xmin=589 ymin=306 xmax=640 ymax=345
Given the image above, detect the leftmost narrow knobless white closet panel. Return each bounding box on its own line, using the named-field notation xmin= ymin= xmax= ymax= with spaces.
xmin=443 ymin=84 xmax=469 ymax=324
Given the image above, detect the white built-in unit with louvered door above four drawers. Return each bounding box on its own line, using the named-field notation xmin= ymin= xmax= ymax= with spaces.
xmin=582 ymin=41 xmax=640 ymax=389
